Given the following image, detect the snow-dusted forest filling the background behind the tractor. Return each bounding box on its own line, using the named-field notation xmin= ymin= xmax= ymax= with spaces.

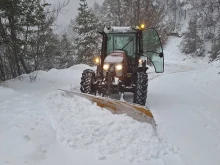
xmin=0 ymin=0 xmax=220 ymax=81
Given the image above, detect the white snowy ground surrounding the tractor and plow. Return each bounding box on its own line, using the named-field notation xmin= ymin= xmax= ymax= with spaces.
xmin=0 ymin=38 xmax=220 ymax=165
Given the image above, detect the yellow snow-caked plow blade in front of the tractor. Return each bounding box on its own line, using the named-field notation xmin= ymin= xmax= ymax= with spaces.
xmin=61 ymin=90 xmax=156 ymax=129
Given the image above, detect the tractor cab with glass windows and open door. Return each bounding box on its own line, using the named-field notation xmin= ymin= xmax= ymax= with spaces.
xmin=101 ymin=26 xmax=164 ymax=73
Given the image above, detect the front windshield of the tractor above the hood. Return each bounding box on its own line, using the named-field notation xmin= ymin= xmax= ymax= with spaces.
xmin=107 ymin=34 xmax=136 ymax=56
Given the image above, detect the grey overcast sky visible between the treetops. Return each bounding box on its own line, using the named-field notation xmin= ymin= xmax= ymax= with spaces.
xmin=46 ymin=0 xmax=104 ymax=27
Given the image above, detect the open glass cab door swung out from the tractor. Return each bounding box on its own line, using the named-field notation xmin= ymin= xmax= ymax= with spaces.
xmin=142 ymin=29 xmax=164 ymax=73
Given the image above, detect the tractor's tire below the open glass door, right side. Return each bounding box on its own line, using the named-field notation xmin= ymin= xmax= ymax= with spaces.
xmin=133 ymin=72 xmax=148 ymax=106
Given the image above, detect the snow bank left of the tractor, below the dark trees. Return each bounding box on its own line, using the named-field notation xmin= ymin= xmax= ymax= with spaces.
xmin=5 ymin=64 xmax=94 ymax=93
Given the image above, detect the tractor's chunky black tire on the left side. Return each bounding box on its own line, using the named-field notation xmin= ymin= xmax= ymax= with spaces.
xmin=80 ymin=69 xmax=95 ymax=94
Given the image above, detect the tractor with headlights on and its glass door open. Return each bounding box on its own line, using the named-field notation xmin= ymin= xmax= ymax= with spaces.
xmin=80 ymin=24 xmax=164 ymax=106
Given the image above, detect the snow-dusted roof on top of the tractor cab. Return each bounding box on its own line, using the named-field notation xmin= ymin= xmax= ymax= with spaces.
xmin=104 ymin=26 xmax=136 ymax=33
